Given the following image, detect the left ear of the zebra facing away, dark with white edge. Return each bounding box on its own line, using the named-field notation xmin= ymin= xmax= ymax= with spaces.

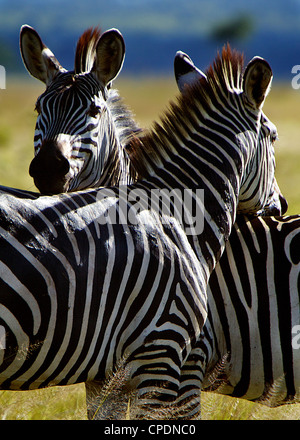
xmin=174 ymin=51 xmax=206 ymax=92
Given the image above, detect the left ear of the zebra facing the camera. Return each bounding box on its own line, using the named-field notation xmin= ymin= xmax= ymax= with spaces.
xmin=20 ymin=25 xmax=65 ymax=85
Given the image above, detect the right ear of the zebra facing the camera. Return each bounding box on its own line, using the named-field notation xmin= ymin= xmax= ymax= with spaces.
xmin=91 ymin=29 xmax=125 ymax=87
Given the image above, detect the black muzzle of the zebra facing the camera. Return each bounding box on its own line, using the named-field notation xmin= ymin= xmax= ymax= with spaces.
xmin=29 ymin=141 xmax=70 ymax=194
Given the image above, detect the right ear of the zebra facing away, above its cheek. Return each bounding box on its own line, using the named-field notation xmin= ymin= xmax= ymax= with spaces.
xmin=243 ymin=57 xmax=273 ymax=110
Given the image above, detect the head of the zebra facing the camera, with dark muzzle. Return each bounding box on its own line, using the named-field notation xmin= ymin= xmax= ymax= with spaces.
xmin=20 ymin=25 xmax=130 ymax=194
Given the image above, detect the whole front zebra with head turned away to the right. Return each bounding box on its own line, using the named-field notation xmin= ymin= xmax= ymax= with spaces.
xmin=0 ymin=46 xmax=280 ymax=418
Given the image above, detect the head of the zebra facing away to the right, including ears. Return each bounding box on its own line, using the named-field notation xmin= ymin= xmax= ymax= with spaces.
xmin=174 ymin=51 xmax=288 ymax=215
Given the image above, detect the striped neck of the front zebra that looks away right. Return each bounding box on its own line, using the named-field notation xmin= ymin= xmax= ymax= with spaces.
xmin=127 ymin=96 xmax=255 ymax=279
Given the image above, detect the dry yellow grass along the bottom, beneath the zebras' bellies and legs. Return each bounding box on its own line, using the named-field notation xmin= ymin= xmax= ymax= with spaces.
xmin=0 ymin=372 xmax=300 ymax=420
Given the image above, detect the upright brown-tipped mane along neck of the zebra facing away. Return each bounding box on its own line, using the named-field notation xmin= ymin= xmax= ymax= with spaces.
xmin=126 ymin=44 xmax=244 ymax=178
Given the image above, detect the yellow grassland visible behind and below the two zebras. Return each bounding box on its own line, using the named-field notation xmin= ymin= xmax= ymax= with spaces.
xmin=0 ymin=78 xmax=300 ymax=420
